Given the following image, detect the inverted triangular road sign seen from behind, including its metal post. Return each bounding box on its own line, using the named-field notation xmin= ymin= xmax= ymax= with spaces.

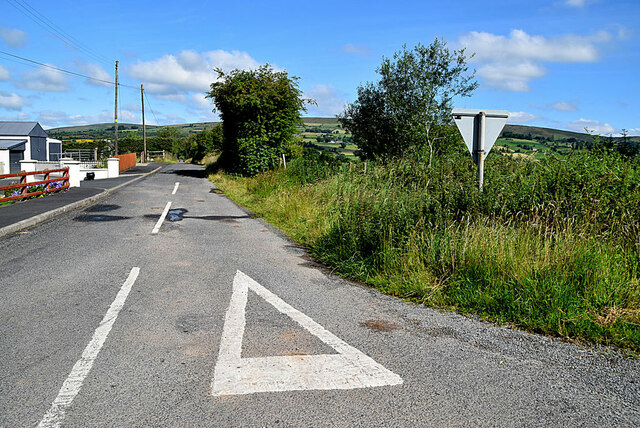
xmin=451 ymin=109 xmax=509 ymax=192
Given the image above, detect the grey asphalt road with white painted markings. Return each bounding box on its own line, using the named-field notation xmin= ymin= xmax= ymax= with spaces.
xmin=0 ymin=164 xmax=640 ymax=427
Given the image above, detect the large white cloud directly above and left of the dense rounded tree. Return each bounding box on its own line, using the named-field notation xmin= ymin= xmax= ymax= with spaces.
xmin=127 ymin=50 xmax=260 ymax=95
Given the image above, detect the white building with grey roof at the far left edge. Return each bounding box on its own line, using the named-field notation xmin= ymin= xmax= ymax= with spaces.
xmin=0 ymin=122 xmax=62 ymax=174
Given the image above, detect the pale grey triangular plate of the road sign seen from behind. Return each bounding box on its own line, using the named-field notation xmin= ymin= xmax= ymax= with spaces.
xmin=451 ymin=108 xmax=509 ymax=159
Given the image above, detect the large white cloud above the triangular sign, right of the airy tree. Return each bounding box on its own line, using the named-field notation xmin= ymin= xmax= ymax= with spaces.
xmin=459 ymin=30 xmax=612 ymax=92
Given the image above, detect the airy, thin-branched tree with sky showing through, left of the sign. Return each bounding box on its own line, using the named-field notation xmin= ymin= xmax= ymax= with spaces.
xmin=339 ymin=39 xmax=478 ymax=160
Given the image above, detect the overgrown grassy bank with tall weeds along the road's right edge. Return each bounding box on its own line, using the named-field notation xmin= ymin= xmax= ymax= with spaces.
xmin=212 ymin=150 xmax=640 ymax=351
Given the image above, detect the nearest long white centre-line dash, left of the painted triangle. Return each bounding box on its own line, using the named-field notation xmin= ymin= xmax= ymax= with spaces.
xmin=38 ymin=267 xmax=140 ymax=428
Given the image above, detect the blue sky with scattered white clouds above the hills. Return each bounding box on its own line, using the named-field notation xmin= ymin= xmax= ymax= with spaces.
xmin=0 ymin=0 xmax=640 ymax=135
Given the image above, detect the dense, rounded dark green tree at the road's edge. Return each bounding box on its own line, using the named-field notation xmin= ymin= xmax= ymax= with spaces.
xmin=207 ymin=64 xmax=309 ymax=175
